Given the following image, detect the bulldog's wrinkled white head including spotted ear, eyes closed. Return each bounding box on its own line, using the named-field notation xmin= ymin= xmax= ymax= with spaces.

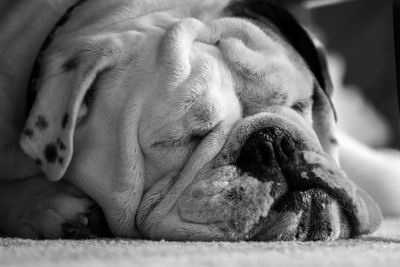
xmin=21 ymin=0 xmax=382 ymax=240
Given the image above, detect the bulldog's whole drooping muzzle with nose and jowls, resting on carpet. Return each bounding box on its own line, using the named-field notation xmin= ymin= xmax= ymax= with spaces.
xmin=138 ymin=115 xmax=380 ymax=240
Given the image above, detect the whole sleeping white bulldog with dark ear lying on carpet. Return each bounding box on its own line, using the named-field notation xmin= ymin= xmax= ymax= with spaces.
xmin=0 ymin=0 xmax=388 ymax=241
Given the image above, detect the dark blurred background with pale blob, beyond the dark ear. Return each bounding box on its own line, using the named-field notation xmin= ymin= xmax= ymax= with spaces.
xmin=287 ymin=0 xmax=400 ymax=148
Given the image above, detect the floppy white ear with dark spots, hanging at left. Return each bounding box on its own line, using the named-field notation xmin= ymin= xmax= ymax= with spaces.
xmin=20 ymin=36 xmax=122 ymax=181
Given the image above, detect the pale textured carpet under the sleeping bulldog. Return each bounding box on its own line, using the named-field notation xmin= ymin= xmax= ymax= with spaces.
xmin=0 ymin=218 xmax=400 ymax=267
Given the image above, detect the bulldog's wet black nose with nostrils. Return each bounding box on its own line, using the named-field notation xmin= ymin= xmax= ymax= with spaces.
xmin=236 ymin=127 xmax=297 ymax=181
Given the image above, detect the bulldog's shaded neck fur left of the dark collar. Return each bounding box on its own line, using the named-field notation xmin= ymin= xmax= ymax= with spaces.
xmin=0 ymin=0 xmax=78 ymax=128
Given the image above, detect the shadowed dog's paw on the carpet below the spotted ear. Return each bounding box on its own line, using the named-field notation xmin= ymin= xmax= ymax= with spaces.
xmin=11 ymin=181 xmax=111 ymax=239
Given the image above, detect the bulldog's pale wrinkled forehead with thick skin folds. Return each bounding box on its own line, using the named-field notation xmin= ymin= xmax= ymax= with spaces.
xmin=133 ymin=14 xmax=312 ymax=102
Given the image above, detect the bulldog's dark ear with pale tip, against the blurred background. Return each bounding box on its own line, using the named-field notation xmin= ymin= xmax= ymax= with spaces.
xmin=225 ymin=0 xmax=338 ymax=160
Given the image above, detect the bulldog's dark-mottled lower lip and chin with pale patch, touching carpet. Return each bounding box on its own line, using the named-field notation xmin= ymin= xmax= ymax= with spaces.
xmin=252 ymin=189 xmax=350 ymax=241
